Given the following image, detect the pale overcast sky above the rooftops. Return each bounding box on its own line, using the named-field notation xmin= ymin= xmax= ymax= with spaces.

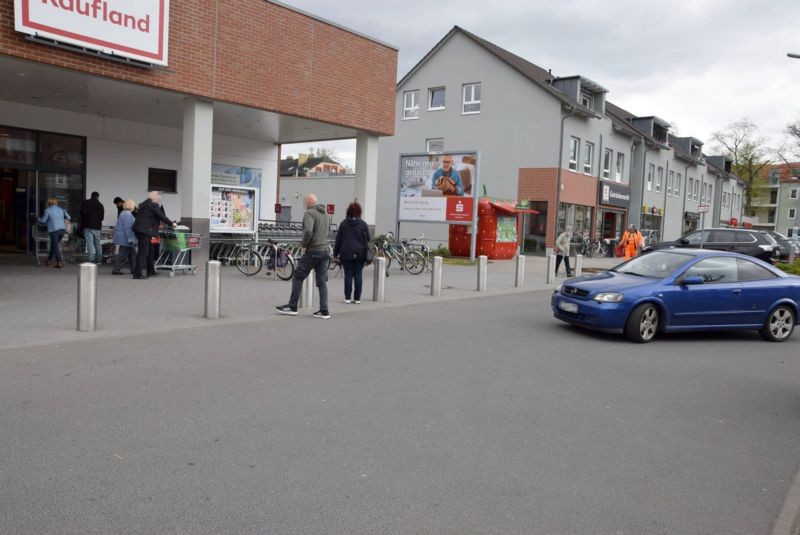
xmin=287 ymin=0 xmax=800 ymax=170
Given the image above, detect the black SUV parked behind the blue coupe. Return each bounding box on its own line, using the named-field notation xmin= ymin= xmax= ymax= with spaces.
xmin=644 ymin=228 xmax=778 ymax=263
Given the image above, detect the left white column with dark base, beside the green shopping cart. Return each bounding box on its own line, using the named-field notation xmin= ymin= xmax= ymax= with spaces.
xmin=180 ymin=98 xmax=214 ymax=266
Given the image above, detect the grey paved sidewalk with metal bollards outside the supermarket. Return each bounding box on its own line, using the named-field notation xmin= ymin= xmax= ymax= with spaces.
xmin=0 ymin=255 xmax=619 ymax=349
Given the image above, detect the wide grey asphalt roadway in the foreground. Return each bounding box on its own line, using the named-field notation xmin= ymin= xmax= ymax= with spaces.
xmin=0 ymin=291 xmax=800 ymax=535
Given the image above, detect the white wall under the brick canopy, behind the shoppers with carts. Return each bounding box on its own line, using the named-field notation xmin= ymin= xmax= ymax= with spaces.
xmin=0 ymin=101 xmax=278 ymax=225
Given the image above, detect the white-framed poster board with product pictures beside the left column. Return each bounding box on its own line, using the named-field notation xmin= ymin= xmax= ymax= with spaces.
xmin=209 ymin=185 xmax=258 ymax=233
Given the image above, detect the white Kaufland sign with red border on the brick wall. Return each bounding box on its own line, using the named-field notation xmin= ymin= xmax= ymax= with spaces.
xmin=14 ymin=0 xmax=169 ymax=66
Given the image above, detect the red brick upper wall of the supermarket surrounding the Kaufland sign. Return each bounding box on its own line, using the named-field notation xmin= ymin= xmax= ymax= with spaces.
xmin=0 ymin=0 xmax=397 ymax=135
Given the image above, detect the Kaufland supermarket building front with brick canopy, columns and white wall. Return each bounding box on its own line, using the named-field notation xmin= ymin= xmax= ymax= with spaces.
xmin=0 ymin=0 xmax=397 ymax=260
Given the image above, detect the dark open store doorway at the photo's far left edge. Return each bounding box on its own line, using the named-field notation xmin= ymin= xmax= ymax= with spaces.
xmin=0 ymin=167 xmax=36 ymax=253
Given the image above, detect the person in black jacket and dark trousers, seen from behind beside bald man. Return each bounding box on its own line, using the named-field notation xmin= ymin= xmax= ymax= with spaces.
xmin=333 ymin=202 xmax=369 ymax=305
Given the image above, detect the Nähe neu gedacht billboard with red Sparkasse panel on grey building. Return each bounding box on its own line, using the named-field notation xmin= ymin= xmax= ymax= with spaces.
xmin=398 ymin=151 xmax=478 ymax=224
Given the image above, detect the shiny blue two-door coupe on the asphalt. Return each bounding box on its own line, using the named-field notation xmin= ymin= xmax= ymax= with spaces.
xmin=551 ymin=249 xmax=800 ymax=343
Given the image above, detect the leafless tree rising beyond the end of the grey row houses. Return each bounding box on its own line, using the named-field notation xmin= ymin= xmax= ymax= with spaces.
xmin=711 ymin=117 xmax=773 ymax=210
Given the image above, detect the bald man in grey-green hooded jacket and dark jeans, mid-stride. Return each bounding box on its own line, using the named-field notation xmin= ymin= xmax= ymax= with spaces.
xmin=275 ymin=193 xmax=331 ymax=319
